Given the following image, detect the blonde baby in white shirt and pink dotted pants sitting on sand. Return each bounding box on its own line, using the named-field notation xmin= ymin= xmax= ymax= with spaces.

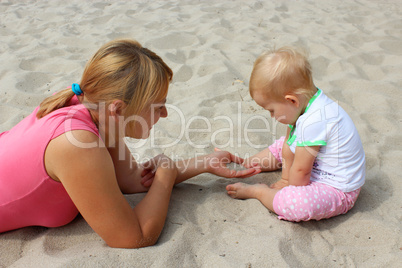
xmin=226 ymin=47 xmax=365 ymax=222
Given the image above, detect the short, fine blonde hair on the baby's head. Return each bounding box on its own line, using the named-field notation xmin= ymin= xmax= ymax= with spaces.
xmin=250 ymin=47 xmax=315 ymax=100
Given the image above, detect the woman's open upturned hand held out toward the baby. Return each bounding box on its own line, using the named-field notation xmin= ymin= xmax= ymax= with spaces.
xmin=205 ymin=148 xmax=261 ymax=178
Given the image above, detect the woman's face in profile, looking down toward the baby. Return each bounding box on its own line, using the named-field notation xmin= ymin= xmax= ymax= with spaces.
xmin=130 ymin=99 xmax=168 ymax=139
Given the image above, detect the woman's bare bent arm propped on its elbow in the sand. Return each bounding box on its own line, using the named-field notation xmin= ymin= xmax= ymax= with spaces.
xmin=45 ymin=130 xmax=177 ymax=248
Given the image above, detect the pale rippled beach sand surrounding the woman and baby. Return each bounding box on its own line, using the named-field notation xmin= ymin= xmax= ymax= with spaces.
xmin=0 ymin=0 xmax=402 ymax=267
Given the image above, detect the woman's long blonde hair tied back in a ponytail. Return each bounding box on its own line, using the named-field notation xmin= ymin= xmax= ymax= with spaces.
xmin=36 ymin=39 xmax=173 ymax=135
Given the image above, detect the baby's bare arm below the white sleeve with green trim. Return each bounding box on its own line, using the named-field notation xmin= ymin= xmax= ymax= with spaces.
xmin=289 ymin=146 xmax=320 ymax=186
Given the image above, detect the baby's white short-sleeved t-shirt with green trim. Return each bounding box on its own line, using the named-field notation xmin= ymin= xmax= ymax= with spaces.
xmin=287 ymin=89 xmax=366 ymax=192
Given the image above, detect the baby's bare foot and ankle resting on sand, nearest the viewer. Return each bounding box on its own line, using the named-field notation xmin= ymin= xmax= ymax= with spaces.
xmin=226 ymin=182 xmax=279 ymax=212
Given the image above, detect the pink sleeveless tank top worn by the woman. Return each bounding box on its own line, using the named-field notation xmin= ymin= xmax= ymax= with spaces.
xmin=0 ymin=96 xmax=100 ymax=232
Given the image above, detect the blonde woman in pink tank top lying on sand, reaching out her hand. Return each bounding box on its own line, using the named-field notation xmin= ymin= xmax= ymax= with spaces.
xmin=0 ymin=40 xmax=260 ymax=248
